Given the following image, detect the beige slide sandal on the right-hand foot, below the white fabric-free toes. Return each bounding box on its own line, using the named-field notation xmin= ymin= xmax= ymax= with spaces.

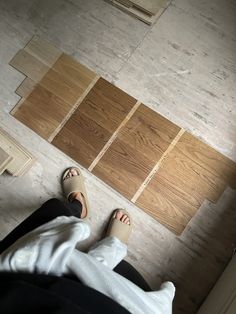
xmin=107 ymin=208 xmax=132 ymax=244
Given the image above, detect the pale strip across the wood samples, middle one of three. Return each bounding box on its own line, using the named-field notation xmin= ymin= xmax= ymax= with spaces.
xmin=88 ymin=101 xmax=141 ymax=171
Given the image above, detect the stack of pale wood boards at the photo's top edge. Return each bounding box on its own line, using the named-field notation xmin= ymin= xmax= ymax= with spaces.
xmin=107 ymin=0 xmax=171 ymax=25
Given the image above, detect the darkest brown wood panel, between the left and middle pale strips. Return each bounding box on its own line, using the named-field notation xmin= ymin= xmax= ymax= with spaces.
xmin=52 ymin=79 xmax=136 ymax=168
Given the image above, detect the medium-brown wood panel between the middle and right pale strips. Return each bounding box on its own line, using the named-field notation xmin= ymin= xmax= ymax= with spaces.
xmin=92 ymin=104 xmax=180 ymax=199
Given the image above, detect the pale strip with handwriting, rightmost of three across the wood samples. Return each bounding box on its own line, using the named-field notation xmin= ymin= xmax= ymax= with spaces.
xmin=131 ymin=129 xmax=185 ymax=203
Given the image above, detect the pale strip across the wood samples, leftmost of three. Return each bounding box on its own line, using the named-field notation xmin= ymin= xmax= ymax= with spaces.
xmin=48 ymin=75 xmax=100 ymax=143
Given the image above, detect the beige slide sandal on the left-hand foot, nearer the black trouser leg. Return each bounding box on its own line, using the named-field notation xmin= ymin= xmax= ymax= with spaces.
xmin=62 ymin=167 xmax=89 ymax=219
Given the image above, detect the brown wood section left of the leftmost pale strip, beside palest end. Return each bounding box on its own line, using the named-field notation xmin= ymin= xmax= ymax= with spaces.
xmin=12 ymin=51 xmax=96 ymax=140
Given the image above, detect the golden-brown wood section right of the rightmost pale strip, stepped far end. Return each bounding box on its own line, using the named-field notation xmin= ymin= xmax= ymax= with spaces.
xmin=136 ymin=133 xmax=236 ymax=234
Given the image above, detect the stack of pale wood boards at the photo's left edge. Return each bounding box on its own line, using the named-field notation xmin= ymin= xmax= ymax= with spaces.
xmin=0 ymin=128 xmax=35 ymax=176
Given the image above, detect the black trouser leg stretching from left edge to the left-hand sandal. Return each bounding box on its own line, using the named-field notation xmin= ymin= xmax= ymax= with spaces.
xmin=0 ymin=198 xmax=82 ymax=254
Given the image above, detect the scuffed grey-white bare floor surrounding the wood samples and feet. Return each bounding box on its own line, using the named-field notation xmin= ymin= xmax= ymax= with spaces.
xmin=0 ymin=0 xmax=236 ymax=314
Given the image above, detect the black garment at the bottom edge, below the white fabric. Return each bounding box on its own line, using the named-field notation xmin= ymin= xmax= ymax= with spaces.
xmin=0 ymin=273 xmax=129 ymax=314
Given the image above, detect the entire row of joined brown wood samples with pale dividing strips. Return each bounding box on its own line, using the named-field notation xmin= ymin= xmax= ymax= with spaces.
xmin=10 ymin=36 xmax=236 ymax=235
